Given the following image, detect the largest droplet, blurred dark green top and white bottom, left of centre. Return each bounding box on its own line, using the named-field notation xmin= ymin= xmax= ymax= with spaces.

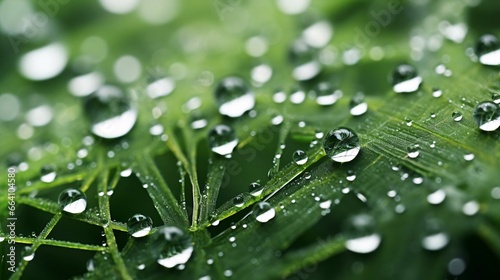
xmin=84 ymin=85 xmax=137 ymax=139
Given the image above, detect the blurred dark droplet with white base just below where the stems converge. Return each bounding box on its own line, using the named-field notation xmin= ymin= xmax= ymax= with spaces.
xmin=153 ymin=226 xmax=193 ymax=268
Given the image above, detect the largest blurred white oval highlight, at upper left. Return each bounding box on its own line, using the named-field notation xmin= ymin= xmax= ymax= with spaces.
xmin=19 ymin=43 xmax=68 ymax=81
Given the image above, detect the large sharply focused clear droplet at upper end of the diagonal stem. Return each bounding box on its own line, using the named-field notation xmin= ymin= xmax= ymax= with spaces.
xmin=323 ymin=127 xmax=361 ymax=162
